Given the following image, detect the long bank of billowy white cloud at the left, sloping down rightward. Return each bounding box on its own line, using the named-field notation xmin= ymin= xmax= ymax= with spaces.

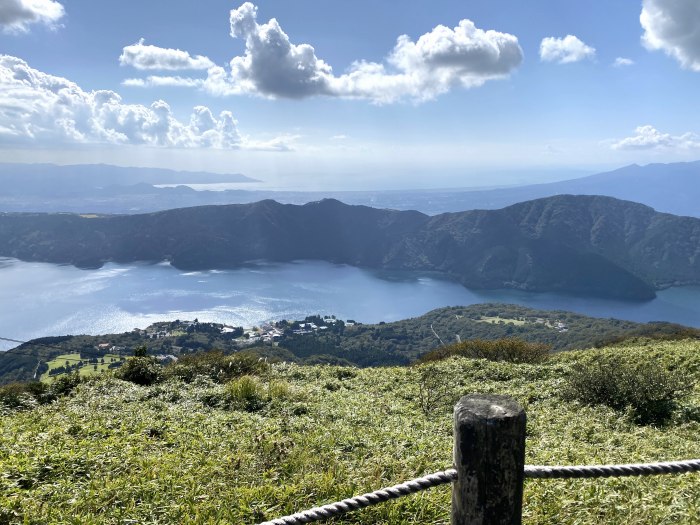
xmin=0 ymin=55 xmax=245 ymax=149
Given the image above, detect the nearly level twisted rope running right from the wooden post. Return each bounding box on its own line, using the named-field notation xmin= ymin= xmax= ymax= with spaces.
xmin=525 ymin=459 xmax=700 ymax=479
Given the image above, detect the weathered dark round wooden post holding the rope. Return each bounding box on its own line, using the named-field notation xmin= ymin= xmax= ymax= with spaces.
xmin=452 ymin=394 xmax=525 ymax=525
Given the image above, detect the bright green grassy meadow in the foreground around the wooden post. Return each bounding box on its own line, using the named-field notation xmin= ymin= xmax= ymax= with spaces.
xmin=0 ymin=341 xmax=700 ymax=524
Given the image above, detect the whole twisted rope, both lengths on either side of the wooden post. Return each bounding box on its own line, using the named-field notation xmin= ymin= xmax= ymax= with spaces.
xmin=259 ymin=459 xmax=700 ymax=525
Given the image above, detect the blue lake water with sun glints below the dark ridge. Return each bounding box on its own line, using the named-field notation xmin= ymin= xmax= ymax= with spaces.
xmin=0 ymin=258 xmax=700 ymax=350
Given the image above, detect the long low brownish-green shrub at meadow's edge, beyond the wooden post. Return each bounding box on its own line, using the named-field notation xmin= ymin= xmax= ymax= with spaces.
xmin=418 ymin=338 xmax=551 ymax=363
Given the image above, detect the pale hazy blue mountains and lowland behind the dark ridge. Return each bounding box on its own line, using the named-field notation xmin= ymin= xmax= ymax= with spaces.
xmin=0 ymin=161 xmax=700 ymax=217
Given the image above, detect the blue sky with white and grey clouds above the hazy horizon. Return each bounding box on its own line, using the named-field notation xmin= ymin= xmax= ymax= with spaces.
xmin=0 ymin=0 xmax=700 ymax=190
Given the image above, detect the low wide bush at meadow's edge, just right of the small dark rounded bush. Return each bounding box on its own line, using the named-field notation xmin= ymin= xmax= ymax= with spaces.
xmin=165 ymin=350 xmax=269 ymax=383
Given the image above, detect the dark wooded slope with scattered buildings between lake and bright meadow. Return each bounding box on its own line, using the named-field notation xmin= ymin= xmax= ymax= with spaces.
xmin=5 ymin=303 xmax=700 ymax=385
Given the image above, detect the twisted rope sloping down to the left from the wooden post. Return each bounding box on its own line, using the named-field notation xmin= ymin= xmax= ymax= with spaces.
xmin=254 ymin=469 xmax=457 ymax=525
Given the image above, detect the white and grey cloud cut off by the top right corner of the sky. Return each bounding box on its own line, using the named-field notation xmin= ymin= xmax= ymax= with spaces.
xmin=639 ymin=0 xmax=700 ymax=71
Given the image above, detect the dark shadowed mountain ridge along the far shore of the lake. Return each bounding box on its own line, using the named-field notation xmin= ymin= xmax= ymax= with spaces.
xmin=0 ymin=195 xmax=700 ymax=300
